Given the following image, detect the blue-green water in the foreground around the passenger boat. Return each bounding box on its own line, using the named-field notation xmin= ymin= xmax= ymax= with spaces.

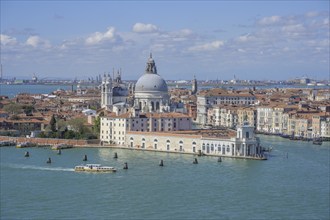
xmin=0 ymin=136 xmax=330 ymax=219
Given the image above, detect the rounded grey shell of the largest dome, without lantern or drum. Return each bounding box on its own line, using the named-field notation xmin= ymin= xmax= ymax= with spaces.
xmin=135 ymin=73 xmax=168 ymax=92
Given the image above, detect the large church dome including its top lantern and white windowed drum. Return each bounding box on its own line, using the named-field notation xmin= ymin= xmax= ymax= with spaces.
xmin=134 ymin=54 xmax=170 ymax=112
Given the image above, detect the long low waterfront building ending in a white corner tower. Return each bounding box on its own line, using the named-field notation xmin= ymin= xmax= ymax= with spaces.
xmin=125 ymin=120 xmax=264 ymax=159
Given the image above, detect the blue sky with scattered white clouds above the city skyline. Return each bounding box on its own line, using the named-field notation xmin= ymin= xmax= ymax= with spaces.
xmin=0 ymin=0 xmax=330 ymax=80
